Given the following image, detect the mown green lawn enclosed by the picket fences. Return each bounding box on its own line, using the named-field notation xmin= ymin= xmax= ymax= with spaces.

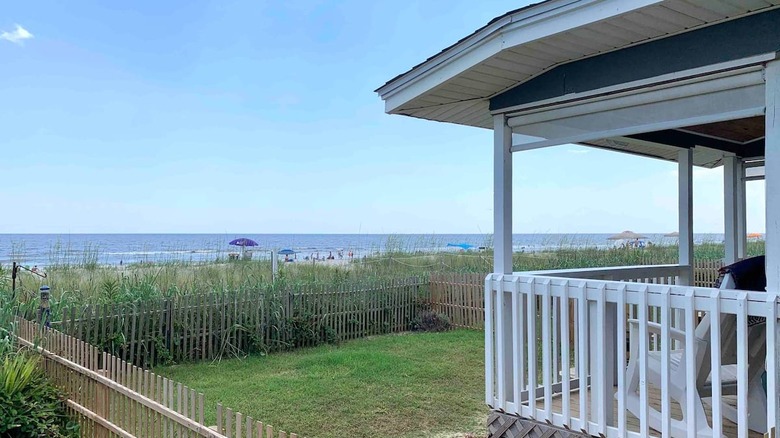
xmin=155 ymin=330 xmax=488 ymax=438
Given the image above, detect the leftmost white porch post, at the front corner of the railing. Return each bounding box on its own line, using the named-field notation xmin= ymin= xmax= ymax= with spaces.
xmin=485 ymin=114 xmax=515 ymax=406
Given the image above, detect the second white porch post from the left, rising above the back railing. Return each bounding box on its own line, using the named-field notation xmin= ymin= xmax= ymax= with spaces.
xmin=677 ymin=149 xmax=693 ymax=286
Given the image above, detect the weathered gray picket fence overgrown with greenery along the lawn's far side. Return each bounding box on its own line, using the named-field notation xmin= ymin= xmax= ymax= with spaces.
xmin=54 ymin=278 xmax=428 ymax=366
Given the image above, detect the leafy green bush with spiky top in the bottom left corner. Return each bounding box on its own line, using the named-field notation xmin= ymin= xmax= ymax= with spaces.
xmin=0 ymin=352 xmax=79 ymax=438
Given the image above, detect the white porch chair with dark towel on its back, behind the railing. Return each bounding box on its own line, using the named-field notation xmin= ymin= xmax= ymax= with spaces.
xmin=624 ymin=256 xmax=767 ymax=438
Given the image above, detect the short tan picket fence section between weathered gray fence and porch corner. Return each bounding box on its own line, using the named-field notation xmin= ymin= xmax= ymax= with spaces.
xmin=430 ymin=274 xmax=485 ymax=330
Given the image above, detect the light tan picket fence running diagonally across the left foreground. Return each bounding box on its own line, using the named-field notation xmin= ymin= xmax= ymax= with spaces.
xmin=16 ymin=318 xmax=298 ymax=438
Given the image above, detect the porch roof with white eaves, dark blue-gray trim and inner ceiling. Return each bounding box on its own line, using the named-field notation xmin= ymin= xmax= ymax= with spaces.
xmin=376 ymin=0 xmax=780 ymax=167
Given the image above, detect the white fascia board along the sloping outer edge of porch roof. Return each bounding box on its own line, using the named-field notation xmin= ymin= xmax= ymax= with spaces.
xmin=377 ymin=0 xmax=662 ymax=113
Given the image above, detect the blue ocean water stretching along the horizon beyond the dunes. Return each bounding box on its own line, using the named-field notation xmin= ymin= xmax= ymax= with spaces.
xmin=0 ymin=233 xmax=723 ymax=266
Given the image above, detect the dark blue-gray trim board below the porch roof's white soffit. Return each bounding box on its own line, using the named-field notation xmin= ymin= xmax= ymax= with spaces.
xmin=490 ymin=9 xmax=780 ymax=111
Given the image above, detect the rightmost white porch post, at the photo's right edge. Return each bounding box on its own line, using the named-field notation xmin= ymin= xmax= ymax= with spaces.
xmin=764 ymin=61 xmax=780 ymax=436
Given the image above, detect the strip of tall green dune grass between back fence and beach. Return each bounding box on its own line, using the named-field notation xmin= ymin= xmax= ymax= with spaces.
xmin=0 ymin=241 xmax=764 ymax=318
